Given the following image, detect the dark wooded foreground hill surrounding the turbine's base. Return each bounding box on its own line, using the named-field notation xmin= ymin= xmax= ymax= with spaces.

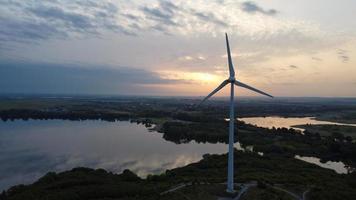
xmin=0 ymin=151 xmax=356 ymax=200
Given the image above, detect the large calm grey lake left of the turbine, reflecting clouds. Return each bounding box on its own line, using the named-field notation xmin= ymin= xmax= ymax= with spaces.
xmin=0 ymin=120 xmax=240 ymax=191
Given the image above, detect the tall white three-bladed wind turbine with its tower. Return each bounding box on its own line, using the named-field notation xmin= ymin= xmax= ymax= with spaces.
xmin=199 ymin=33 xmax=273 ymax=193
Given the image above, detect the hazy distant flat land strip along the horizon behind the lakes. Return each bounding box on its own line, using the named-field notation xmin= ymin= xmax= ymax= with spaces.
xmin=0 ymin=95 xmax=356 ymax=123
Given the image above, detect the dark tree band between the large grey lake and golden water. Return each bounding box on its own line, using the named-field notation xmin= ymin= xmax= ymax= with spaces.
xmin=162 ymin=121 xmax=356 ymax=168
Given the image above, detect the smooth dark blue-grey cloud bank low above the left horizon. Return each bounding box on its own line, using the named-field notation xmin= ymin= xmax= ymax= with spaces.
xmin=0 ymin=62 xmax=183 ymax=94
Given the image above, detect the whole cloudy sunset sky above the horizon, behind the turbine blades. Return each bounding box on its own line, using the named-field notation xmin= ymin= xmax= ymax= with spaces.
xmin=0 ymin=0 xmax=356 ymax=97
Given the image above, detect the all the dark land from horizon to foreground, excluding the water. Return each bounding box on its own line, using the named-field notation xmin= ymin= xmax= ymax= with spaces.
xmin=0 ymin=97 xmax=356 ymax=200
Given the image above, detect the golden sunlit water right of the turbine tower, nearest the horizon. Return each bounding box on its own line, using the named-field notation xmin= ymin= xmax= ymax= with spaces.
xmin=239 ymin=117 xmax=356 ymax=130
